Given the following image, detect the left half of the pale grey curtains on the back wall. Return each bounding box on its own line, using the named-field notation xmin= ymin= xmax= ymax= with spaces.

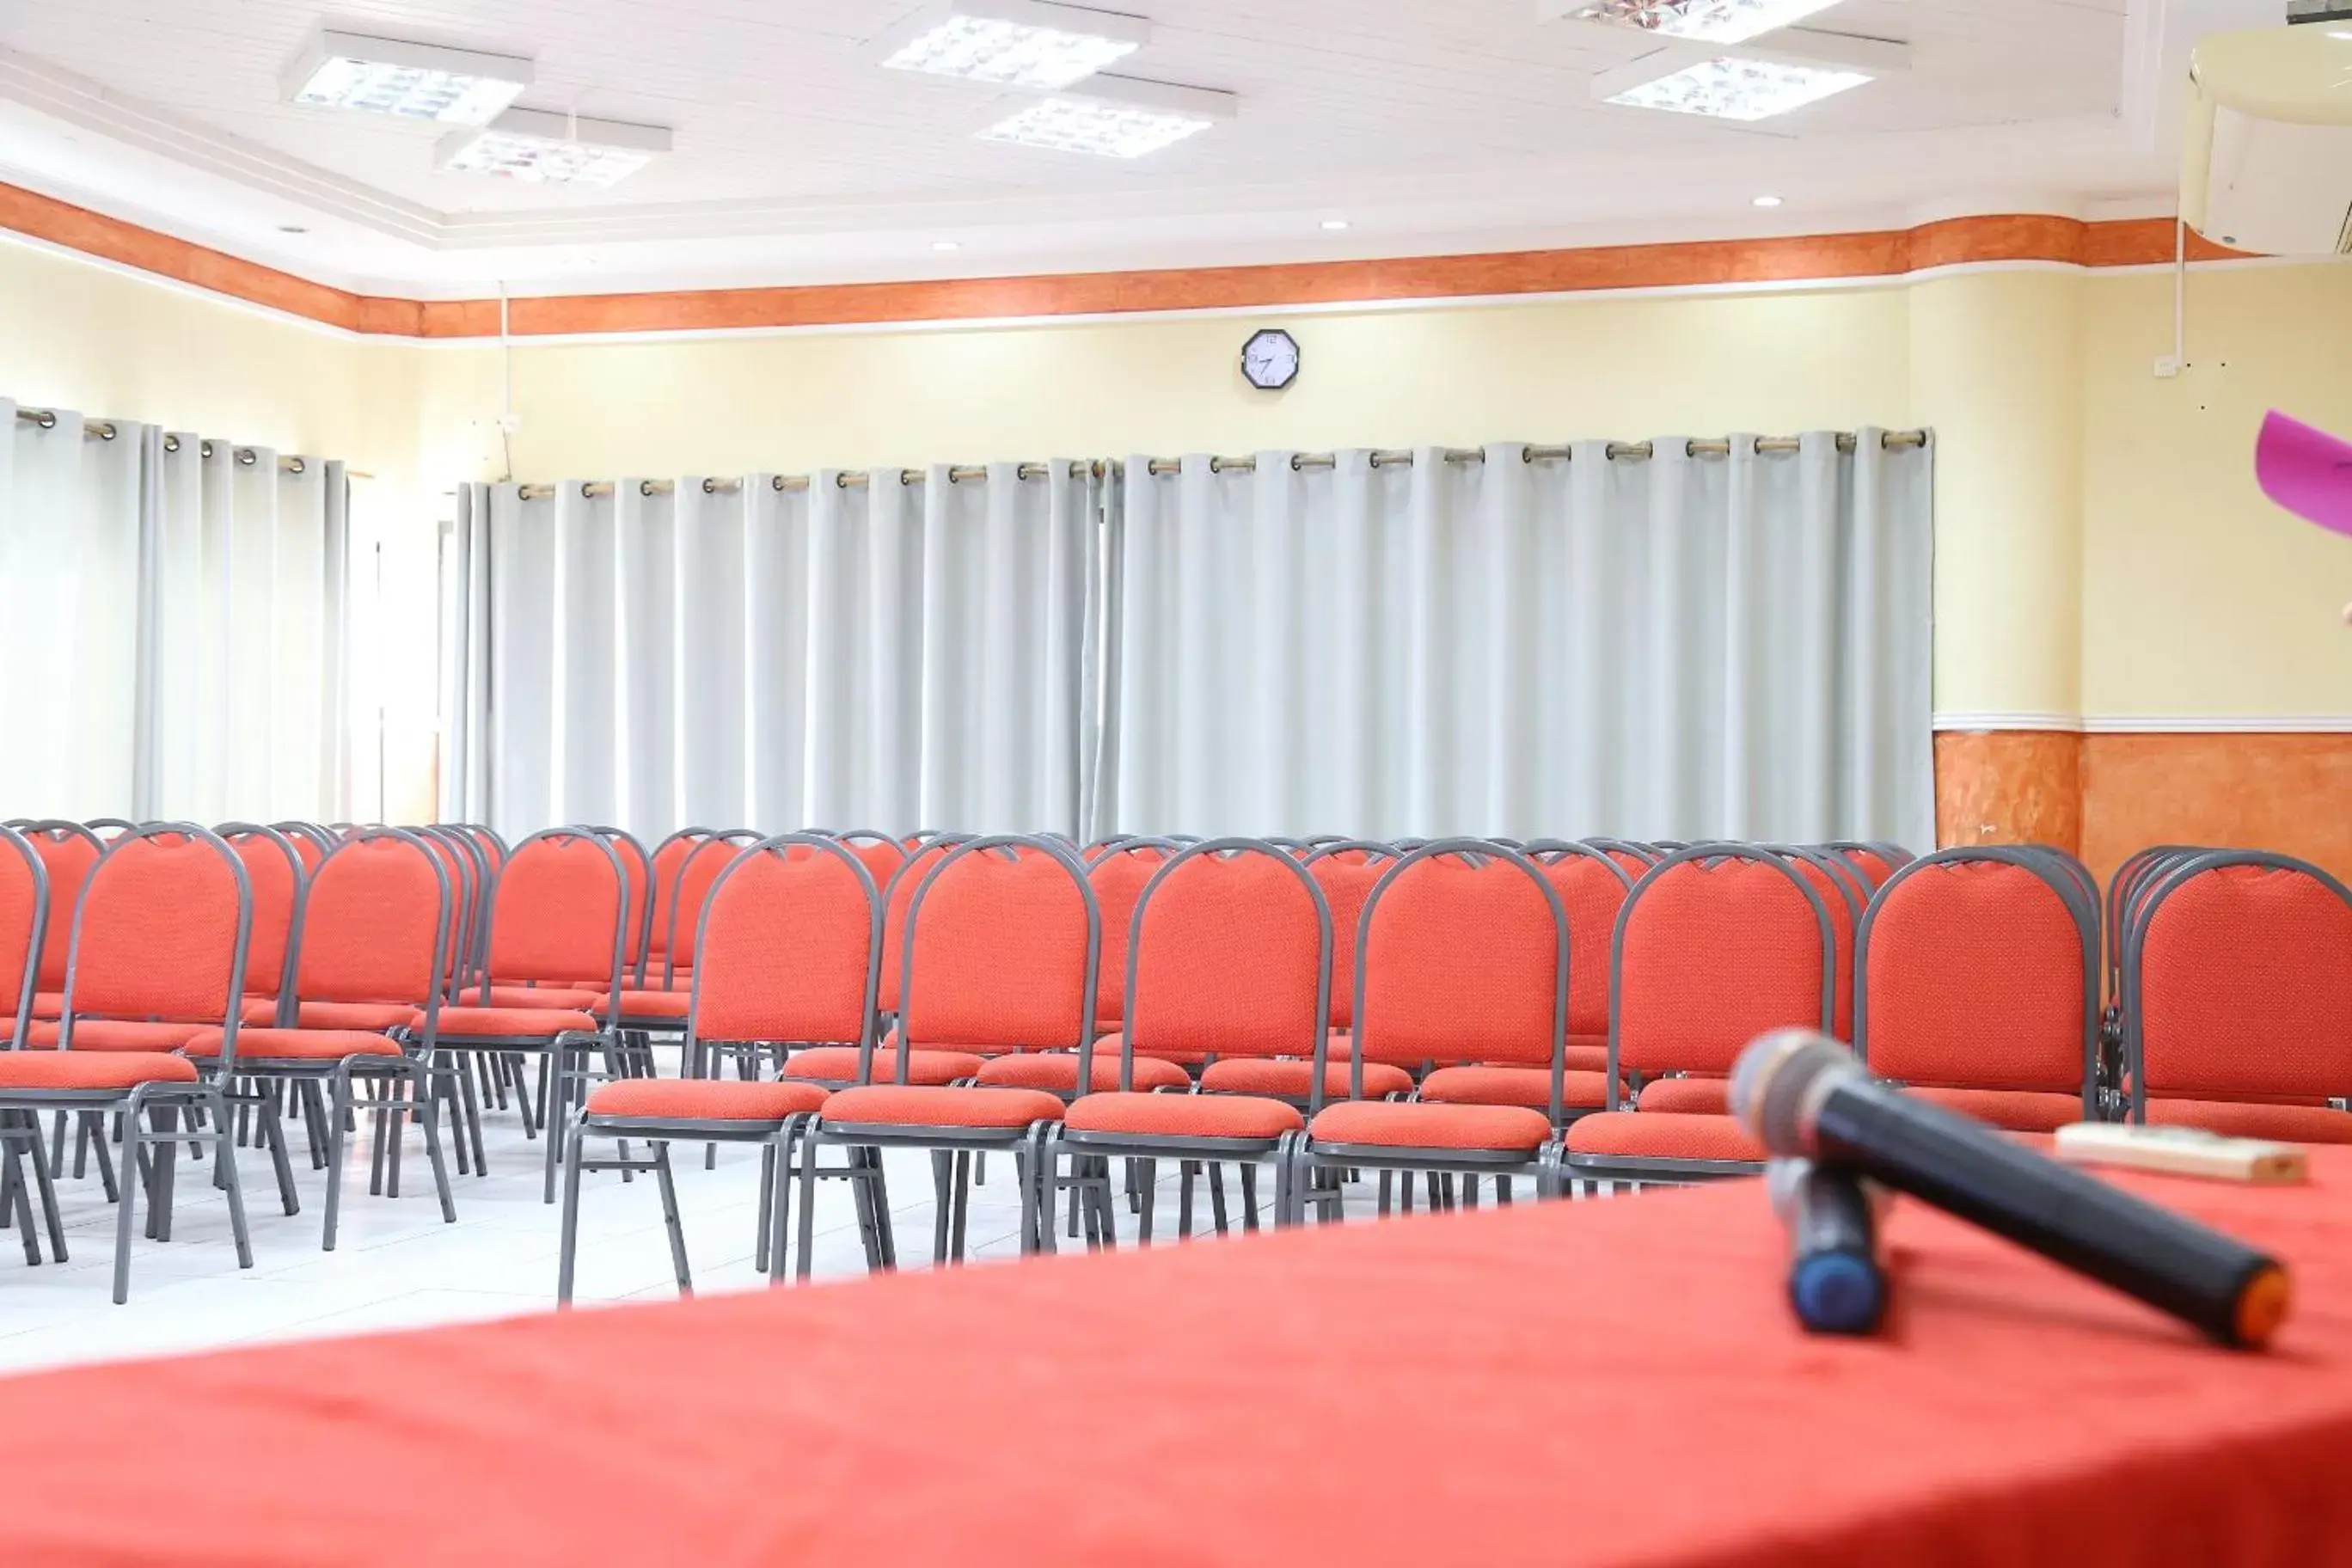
xmin=442 ymin=463 xmax=1100 ymax=839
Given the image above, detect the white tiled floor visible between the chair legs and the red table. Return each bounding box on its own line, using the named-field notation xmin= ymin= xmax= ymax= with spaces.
xmin=0 ymin=1060 xmax=1411 ymax=1373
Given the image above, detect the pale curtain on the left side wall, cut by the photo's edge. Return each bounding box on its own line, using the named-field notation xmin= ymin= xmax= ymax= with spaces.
xmin=0 ymin=400 xmax=351 ymax=823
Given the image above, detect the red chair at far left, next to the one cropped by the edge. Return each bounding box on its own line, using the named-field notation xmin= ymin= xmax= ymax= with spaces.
xmin=0 ymin=823 xmax=254 ymax=1305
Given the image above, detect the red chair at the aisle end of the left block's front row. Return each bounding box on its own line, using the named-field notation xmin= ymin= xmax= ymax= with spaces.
xmin=426 ymin=828 xmax=628 ymax=1204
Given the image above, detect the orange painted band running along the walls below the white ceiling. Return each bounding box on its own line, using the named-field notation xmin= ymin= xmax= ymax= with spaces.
xmin=0 ymin=183 xmax=2239 ymax=341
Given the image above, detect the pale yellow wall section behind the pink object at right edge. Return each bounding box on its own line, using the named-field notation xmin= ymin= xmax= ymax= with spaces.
xmin=2081 ymin=266 xmax=2352 ymax=717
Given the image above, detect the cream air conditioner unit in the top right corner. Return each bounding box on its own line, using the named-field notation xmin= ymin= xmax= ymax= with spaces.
xmin=2180 ymin=23 xmax=2352 ymax=256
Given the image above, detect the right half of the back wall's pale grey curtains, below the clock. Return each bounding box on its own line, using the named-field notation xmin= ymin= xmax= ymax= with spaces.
xmin=1089 ymin=430 xmax=1936 ymax=846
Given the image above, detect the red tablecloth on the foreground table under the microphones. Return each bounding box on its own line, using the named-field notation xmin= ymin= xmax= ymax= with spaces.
xmin=0 ymin=1149 xmax=2352 ymax=1568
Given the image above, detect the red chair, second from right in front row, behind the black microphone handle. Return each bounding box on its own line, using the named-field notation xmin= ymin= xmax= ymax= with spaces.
xmin=1853 ymin=846 xmax=2100 ymax=1133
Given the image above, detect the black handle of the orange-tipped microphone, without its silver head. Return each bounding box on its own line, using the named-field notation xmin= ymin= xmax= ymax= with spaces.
xmin=1813 ymin=1081 xmax=2286 ymax=1344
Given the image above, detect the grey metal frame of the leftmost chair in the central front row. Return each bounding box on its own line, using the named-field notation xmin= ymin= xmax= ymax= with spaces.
xmin=555 ymin=832 xmax=889 ymax=1307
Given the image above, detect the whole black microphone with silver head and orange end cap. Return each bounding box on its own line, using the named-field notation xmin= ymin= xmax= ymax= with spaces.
xmin=1731 ymin=1030 xmax=2291 ymax=1347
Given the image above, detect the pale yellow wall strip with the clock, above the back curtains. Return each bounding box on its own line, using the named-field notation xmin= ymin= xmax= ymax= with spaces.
xmin=423 ymin=289 xmax=1908 ymax=480
